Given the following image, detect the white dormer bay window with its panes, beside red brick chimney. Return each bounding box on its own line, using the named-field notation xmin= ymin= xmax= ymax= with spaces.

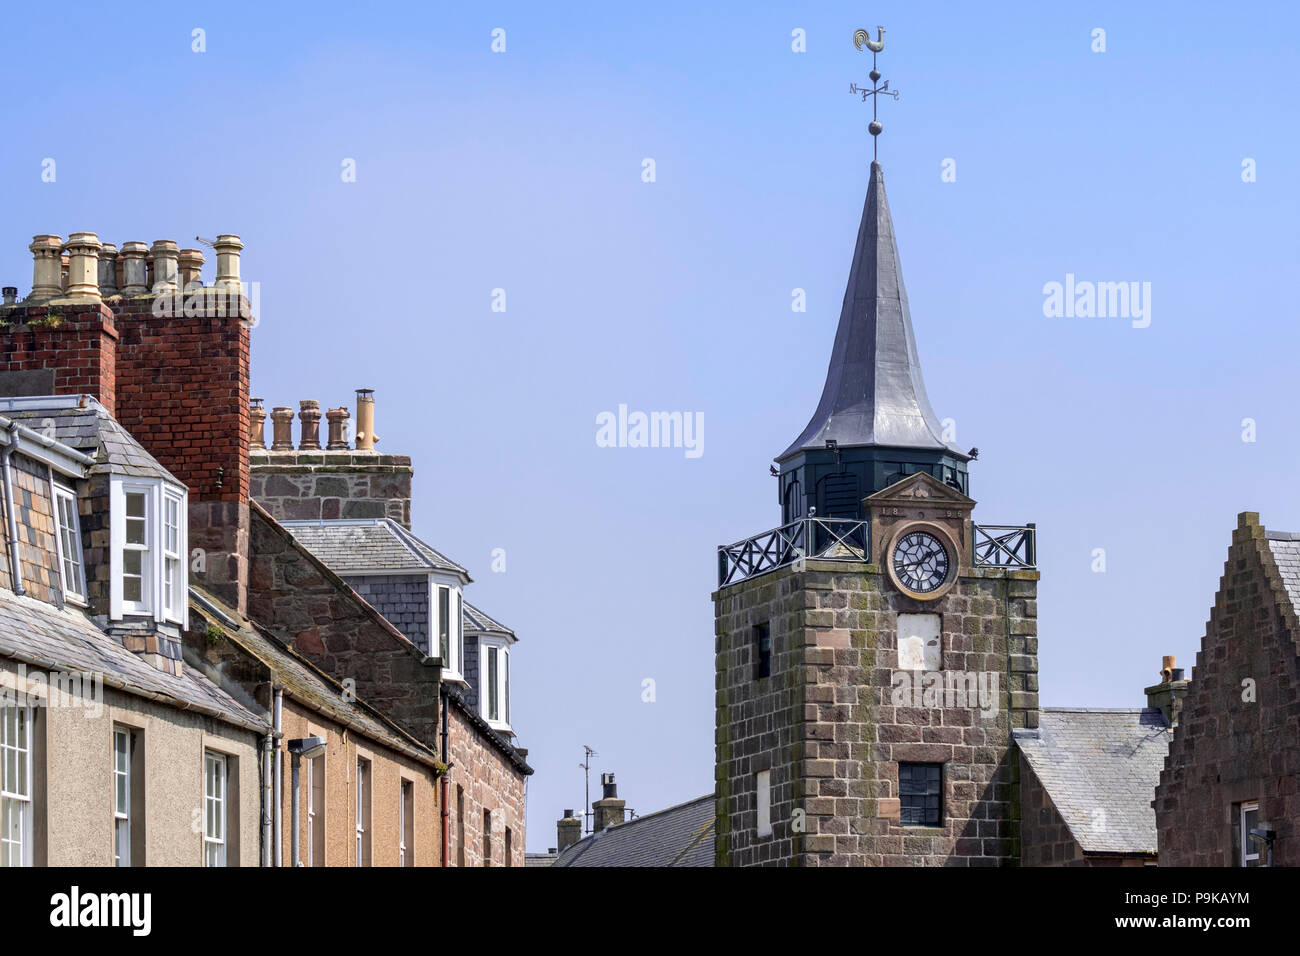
xmin=109 ymin=476 xmax=189 ymax=627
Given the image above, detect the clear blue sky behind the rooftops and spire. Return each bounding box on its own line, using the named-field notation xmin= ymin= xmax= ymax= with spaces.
xmin=0 ymin=3 xmax=1300 ymax=849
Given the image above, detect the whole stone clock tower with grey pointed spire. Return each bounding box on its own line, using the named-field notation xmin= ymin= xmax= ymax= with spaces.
xmin=714 ymin=39 xmax=1039 ymax=866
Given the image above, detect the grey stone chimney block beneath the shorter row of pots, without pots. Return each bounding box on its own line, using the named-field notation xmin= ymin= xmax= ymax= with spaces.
xmin=251 ymin=451 xmax=413 ymax=528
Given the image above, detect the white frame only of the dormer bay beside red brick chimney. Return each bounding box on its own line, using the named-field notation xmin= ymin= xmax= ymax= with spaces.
xmin=109 ymin=476 xmax=190 ymax=627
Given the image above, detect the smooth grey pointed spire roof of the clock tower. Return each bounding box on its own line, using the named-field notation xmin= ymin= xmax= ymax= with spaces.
xmin=777 ymin=163 xmax=970 ymax=462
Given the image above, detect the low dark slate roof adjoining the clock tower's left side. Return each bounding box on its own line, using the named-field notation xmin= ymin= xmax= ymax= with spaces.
xmin=555 ymin=793 xmax=716 ymax=866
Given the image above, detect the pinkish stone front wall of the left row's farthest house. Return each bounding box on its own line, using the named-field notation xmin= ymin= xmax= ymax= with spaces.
xmin=449 ymin=704 xmax=525 ymax=866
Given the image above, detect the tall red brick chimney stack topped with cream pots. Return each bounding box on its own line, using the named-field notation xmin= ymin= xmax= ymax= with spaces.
xmin=0 ymin=226 xmax=254 ymax=613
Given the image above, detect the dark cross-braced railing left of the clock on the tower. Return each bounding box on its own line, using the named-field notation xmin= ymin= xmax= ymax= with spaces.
xmin=718 ymin=518 xmax=871 ymax=588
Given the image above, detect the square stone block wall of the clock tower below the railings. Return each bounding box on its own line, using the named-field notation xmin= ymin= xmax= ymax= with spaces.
xmin=714 ymin=561 xmax=1037 ymax=866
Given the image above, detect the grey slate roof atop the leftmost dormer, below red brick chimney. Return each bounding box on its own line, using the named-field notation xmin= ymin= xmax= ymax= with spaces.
xmin=3 ymin=395 xmax=182 ymax=484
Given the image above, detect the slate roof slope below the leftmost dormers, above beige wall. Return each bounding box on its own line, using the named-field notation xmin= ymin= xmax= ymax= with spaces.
xmin=0 ymin=592 xmax=267 ymax=732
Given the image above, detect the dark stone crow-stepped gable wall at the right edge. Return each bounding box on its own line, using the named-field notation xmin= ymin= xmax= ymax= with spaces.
xmin=1154 ymin=512 xmax=1300 ymax=866
